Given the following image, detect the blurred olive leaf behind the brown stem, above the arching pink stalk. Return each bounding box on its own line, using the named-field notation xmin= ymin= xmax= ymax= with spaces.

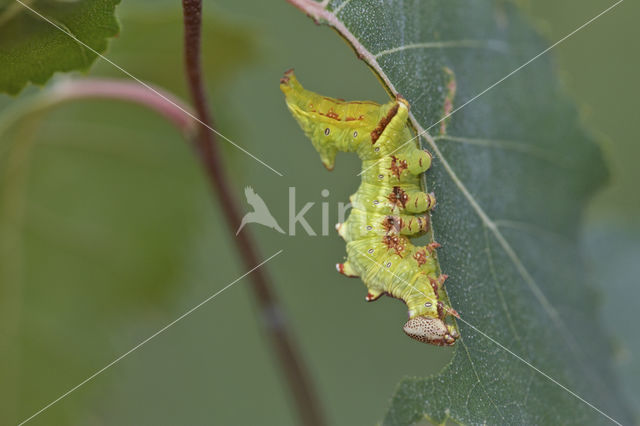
xmin=92 ymin=2 xmax=258 ymax=97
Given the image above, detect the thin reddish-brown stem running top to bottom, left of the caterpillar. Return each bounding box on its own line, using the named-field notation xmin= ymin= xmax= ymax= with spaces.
xmin=182 ymin=0 xmax=324 ymax=426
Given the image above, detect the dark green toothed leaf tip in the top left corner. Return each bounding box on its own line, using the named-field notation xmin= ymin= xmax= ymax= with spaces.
xmin=0 ymin=0 xmax=120 ymax=94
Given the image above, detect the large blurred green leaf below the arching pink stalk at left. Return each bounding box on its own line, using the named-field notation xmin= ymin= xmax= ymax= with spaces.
xmin=0 ymin=11 xmax=260 ymax=424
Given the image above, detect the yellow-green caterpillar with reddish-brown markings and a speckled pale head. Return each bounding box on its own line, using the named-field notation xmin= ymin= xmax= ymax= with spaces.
xmin=280 ymin=70 xmax=459 ymax=346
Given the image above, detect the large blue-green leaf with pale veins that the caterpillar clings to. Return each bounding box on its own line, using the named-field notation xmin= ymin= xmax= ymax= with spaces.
xmin=292 ymin=0 xmax=630 ymax=425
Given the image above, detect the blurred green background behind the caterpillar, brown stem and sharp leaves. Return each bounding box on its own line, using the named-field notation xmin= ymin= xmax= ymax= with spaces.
xmin=0 ymin=0 xmax=640 ymax=425
